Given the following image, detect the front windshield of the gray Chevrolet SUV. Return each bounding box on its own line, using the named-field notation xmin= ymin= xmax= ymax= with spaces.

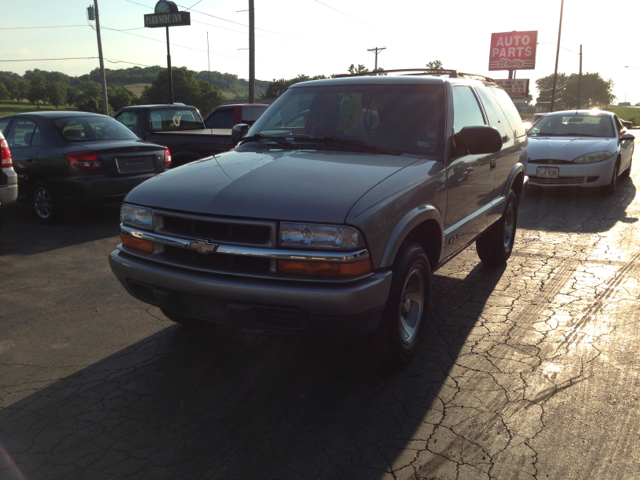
xmin=244 ymin=84 xmax=444 ymax=155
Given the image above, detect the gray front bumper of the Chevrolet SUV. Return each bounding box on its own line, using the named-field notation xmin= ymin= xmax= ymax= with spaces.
xmin=109 ymin=250 xmax=391 ymax=336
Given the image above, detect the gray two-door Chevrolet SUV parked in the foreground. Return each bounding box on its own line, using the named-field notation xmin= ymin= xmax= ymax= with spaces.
xmin=110 ymin=70 xmax=528 ymax=363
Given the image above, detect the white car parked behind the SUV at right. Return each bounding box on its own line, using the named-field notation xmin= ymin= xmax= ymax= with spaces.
xmin=527 ymin=110 xmax=635 ymax=194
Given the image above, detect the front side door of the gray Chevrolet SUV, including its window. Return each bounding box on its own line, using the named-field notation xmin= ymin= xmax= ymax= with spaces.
xmin=445 ymin=85 xmax=496 ymax=254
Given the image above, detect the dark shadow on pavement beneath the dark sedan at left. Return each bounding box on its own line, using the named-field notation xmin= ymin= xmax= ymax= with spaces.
xmin=0 ymin=203 xmax=120 ymax=256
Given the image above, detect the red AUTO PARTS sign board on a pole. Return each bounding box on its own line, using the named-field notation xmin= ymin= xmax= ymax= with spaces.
xmin=489 ymin=31 xmax=538 ymax=70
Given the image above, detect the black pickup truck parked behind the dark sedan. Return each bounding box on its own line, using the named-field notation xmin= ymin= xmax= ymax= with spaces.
xmin=114 ymin=103 xmax=233 ymax=167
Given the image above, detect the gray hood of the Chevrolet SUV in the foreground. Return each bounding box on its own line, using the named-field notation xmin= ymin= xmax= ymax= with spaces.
xmin=125 ymin=150 xmax=416 ymax=223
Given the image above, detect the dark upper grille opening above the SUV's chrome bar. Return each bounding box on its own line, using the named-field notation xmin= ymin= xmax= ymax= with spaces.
xmin=156 ymin=212 xmax=275 ymax=247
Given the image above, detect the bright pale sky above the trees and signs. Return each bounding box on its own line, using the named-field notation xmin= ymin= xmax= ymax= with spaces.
xmin=0 ymin=0 xmax=640 ymax=104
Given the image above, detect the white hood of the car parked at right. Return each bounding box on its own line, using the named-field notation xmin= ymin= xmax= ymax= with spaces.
xmin=529 ymin=137 xmax=617 ymax=161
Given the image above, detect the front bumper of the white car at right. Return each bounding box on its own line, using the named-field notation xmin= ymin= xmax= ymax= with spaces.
xmin=526 ymin=157 xmax=616 ymax=188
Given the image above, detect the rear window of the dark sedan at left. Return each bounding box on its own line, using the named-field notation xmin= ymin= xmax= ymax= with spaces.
xmin=53 ymin=115 xmax=138 ymax=142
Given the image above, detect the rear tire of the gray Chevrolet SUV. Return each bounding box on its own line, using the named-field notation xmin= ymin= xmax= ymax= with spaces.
xmin=476 ymin=190 xmax=518 ymax=267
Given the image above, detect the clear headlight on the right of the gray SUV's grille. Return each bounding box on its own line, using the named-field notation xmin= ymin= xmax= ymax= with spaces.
xmin=280 ymin=223 xmax=364 ymax=250
